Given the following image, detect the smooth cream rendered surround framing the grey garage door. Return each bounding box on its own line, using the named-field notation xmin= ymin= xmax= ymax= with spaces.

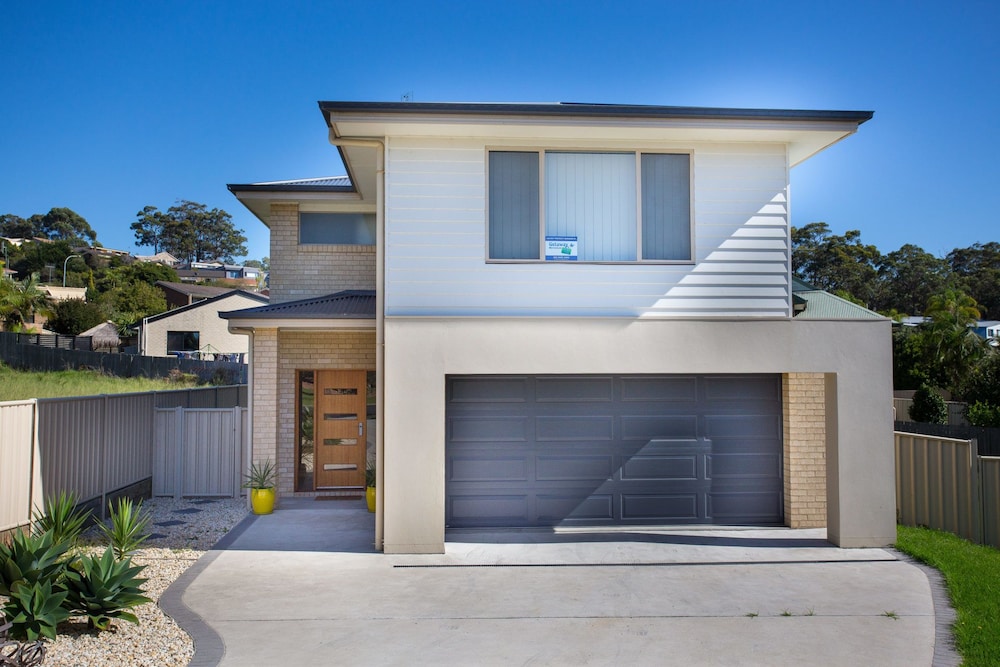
xmin=381 ymin=318 xmax=896 ymax=553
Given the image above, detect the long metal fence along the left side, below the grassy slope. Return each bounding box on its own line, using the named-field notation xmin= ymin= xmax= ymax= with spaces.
xmin=0 ymin=385 xmax=247 ymax=532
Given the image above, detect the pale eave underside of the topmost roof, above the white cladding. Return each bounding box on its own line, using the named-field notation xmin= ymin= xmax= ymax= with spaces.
xmin=329 ymin=112 xmax=858 ymax=166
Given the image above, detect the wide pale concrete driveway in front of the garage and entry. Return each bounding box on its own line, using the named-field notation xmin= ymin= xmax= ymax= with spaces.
xmin=161 ymin=500 xmax=952 ymax=667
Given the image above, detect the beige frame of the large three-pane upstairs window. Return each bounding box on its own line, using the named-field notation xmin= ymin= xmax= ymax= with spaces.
xmin=484 ymin=145 xmax=696 ymax=266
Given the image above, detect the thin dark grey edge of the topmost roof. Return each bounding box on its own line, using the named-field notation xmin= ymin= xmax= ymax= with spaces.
xmin=319 ymin=101 xmax=874 ymax=124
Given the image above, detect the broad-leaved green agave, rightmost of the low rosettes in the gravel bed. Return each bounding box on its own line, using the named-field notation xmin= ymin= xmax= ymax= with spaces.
xmin=63 ymin=546 xmax=152 ymax=631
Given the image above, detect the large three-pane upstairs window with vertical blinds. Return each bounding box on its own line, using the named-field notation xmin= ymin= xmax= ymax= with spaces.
xmin=489 ymin=150 xmax=692 ymax=262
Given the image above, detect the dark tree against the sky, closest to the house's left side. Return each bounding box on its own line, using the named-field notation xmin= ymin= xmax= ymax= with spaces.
xmin=131 ymin=200 xmax=247 ymax=262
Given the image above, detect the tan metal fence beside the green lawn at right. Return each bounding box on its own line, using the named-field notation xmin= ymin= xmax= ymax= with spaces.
xmin=895 ymin=431 xmax=1000 ymax=548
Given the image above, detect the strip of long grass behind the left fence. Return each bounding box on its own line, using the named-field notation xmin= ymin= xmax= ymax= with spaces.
xmin=0 ymin=364 xmax=194 ymax=401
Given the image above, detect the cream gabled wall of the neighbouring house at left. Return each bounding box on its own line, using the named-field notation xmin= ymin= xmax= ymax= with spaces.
xmin=143 ymin=294 xmax=266 ymax=357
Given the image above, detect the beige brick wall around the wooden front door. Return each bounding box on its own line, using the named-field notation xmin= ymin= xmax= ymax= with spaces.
xmin=272 ymin=331 xmax=375 ymax=495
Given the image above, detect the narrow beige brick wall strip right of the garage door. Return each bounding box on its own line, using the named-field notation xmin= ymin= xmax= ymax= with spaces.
xmin=781 ymin=373 xmax=826 ymax=528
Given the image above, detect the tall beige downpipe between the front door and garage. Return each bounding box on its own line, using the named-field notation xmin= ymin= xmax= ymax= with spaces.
xmin=332 ymin=132 xmax=385 ymax=551
